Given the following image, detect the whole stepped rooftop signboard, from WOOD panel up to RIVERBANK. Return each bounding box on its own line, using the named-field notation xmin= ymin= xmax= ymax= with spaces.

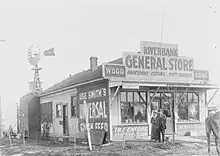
xmin=103 ymin=41 xmax=208 ymax=83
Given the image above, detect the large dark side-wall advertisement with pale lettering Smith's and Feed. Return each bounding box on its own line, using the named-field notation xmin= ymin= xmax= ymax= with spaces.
xmin=78 ymin=81 xmax=109 ymax=141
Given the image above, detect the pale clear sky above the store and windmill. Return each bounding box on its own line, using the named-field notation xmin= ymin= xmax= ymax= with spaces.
xmin=0 ymin=0 xmax=220 ymax=129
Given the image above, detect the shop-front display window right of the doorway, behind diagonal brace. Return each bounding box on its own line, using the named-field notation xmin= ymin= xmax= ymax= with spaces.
xmin=177 ymin=93 xmax=199 ymax=121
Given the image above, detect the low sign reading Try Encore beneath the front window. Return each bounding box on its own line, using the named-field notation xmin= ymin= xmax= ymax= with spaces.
xmin=112 ymin=125 xmax=149 ymax=141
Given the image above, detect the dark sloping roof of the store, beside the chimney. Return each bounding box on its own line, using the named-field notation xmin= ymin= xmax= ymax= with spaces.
xmin=38 ymin=58 xmax=122 ymax=97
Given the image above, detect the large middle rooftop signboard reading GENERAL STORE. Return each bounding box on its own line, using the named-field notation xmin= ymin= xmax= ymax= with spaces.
xmin=123 ymin=52 xmax=194 ymax=83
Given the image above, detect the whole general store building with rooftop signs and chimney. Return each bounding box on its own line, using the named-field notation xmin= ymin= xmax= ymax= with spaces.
xmin=39 ymin=41 xmax=218 ymax=141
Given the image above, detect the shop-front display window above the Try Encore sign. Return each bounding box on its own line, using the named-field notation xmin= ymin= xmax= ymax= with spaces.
xmin=121 ymin=92 xmax=147 ymax=123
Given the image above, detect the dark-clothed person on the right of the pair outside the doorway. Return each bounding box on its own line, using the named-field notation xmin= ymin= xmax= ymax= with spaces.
xmin=156 ymin=110 xmax=166 ymax=142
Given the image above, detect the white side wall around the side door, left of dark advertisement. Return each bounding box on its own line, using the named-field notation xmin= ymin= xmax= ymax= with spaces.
xmin=40 ymin=89 xmax=78 ymax=136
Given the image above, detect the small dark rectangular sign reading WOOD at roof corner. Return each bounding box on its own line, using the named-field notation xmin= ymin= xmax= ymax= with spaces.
xmin=102 ymin=64 xmax=126 ymax=78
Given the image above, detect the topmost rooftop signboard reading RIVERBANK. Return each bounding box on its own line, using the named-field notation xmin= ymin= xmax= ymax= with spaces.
xmin=140 ymin=41 xmax=178 ymax=57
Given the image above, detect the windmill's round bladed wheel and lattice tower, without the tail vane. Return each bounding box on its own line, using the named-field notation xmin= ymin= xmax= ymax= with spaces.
xmin=28 ymin=45 xmax=42 ymax=95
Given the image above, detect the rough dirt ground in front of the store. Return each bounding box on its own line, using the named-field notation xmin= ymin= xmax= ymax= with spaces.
xmin=0 ymin=136 xmax=216 ymax=156
